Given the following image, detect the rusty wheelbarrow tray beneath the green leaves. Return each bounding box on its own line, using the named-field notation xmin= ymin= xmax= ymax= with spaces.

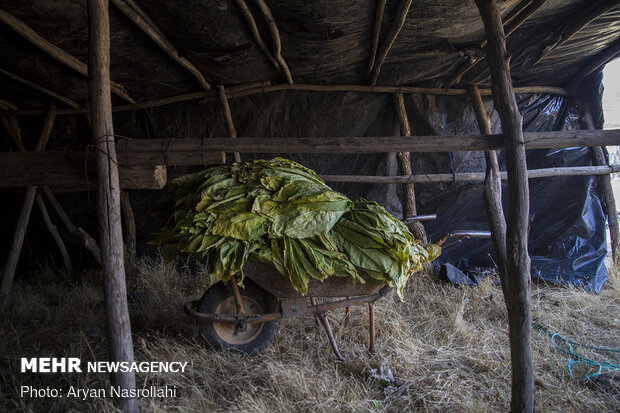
xmin=243 ymin=260 xmax=385 ymax=298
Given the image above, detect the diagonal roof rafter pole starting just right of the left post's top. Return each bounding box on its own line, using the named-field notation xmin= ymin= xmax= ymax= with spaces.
xmin=112 ymin=0 xmax=211 ymax=90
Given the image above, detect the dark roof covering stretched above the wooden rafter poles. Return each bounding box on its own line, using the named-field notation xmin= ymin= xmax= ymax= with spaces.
xmin=0 ymin=0 xmax=620 ymax=108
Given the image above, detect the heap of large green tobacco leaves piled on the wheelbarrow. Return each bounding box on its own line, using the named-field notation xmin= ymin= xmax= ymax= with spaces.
xmin=152 ymin=158 xmax=441 ymax=298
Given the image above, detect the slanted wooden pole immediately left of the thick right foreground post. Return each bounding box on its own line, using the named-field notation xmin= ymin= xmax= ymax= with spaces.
xmin=470 ymin=85 xmax=508 ymax=297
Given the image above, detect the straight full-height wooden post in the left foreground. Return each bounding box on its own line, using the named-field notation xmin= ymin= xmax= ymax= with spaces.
xmin=88 ymin=0 xmax=139 ymax=412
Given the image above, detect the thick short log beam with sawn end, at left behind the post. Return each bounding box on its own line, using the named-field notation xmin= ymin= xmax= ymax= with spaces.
xmin=0 ymin=151 xmax=167 ymax=190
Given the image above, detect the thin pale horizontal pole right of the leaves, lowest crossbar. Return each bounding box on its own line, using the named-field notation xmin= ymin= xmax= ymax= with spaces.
xmin=319 ymin=164 xmax=620 ymax=184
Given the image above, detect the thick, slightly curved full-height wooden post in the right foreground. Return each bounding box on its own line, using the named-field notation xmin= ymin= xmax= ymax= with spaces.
xmin=476 ymin=0 xmax=535 ymax=412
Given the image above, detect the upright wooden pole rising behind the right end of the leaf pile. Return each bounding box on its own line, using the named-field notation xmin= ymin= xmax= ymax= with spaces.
xmin=392 ymin=93 xmax=427 ymax=244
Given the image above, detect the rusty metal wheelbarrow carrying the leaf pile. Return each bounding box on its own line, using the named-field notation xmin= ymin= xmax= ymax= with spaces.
xmin=184 ymin=224 xmax=491 ymax=361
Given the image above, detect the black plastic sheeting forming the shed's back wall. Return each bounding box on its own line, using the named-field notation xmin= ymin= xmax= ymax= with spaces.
xmin=112 ymin=88 xmax=607 ymax=292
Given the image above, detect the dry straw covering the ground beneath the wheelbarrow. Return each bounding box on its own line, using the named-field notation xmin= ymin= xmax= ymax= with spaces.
xmin=0 ymin=259 xmax=620 ymax=412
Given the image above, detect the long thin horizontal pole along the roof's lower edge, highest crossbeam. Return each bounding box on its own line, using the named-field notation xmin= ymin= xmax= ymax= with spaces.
xmin=4 ymin=82 xmax=570 ymax=116
